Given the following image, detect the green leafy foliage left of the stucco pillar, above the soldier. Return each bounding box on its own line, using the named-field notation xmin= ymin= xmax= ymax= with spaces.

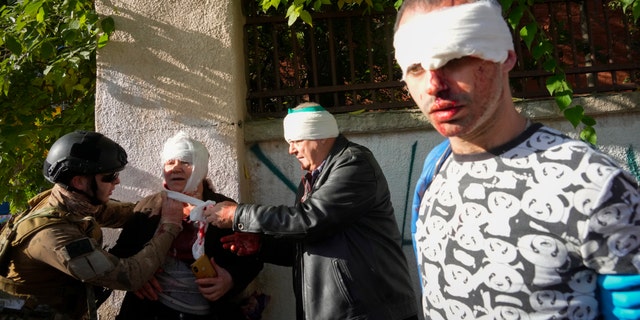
xmin=0 ymin=0 xmax=114 ymax=212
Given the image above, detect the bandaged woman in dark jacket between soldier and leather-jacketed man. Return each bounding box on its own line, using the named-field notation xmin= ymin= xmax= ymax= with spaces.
xmin=111 ymin=132 xmax=262 ymax=320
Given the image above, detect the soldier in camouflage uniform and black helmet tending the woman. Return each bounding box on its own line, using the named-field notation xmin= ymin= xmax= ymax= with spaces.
xmin=0 ymin=131 xmax=182 ymax=319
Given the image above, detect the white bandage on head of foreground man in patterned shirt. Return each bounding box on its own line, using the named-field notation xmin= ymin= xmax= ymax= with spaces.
xmin=393 ymin=1 xmax=513 ymax=78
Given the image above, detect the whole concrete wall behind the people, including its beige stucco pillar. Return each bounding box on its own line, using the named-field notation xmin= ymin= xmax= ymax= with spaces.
xmin=96 ymin=0 xmax=640 ymax=320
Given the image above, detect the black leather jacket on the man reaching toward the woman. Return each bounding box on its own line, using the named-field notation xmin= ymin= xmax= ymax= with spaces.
xmin=233 ymin=135 xmax=417 ymax=320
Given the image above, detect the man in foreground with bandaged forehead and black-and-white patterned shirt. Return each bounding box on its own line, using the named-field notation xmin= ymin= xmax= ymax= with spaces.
xmin=394 ymin=0 xmax=640 ymax=319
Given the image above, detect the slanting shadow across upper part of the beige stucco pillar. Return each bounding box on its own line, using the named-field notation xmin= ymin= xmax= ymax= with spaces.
xmin=96 ymin=0 xmax=237 ymax=131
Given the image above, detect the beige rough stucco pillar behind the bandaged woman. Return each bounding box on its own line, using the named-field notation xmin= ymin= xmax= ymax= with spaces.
xmin=96 ymin=0 xmax=246 ymax=200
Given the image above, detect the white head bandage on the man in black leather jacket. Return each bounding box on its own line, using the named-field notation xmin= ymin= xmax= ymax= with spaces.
xmin=284 ymin=105 xmax=340 ymax=142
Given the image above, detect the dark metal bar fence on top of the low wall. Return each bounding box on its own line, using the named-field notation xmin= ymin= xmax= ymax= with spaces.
xmin=244 ymin=0 xmax=640 ymax=118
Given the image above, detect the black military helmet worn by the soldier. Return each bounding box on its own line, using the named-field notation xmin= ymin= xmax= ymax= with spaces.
xmin=42 ymin=131 xmax=127 ymax=185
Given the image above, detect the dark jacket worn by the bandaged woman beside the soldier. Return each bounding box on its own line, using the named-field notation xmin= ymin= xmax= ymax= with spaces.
xmin=109 ymin=183 xmax=262 ymax=319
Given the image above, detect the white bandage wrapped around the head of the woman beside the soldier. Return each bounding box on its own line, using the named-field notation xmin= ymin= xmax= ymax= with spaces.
xmin=161 ymin=131 xmax=209 ymax=193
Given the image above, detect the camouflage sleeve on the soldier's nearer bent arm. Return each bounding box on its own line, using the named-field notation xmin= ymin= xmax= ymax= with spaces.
xmin=26 ymin=223 xmax=182 ymax=290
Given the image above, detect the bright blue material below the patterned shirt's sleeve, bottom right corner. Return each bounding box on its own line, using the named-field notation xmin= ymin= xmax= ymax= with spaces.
xmin=598 ymin=274 xmax=640 ymax=320
